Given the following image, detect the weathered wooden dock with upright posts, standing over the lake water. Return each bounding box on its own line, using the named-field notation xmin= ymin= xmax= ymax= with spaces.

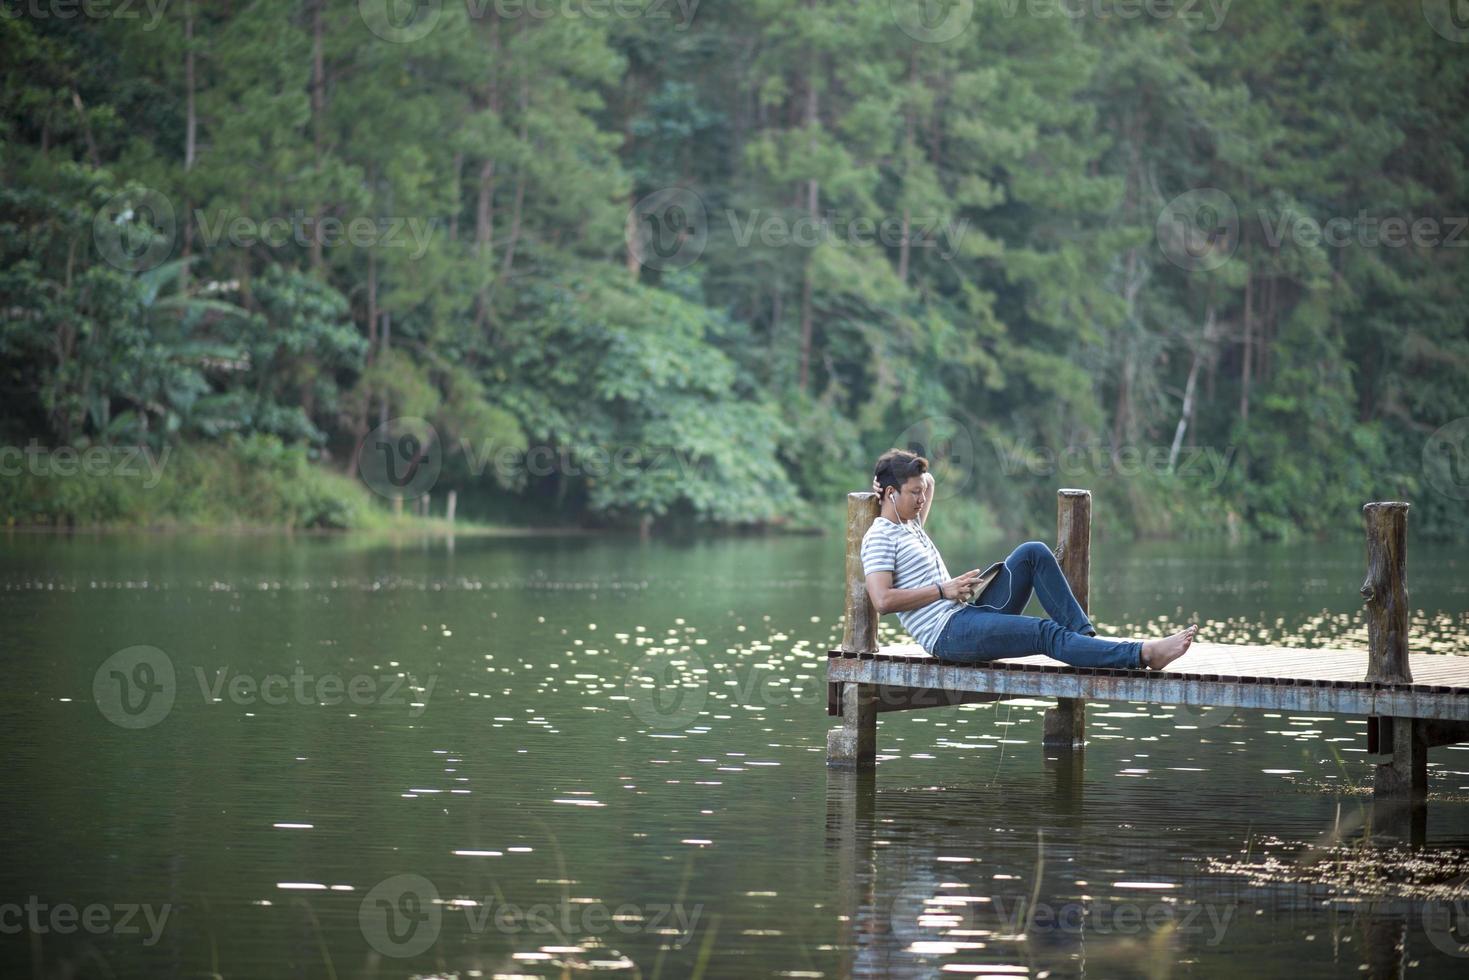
xmin=827 ymin=489 xmax=1469 ymax=836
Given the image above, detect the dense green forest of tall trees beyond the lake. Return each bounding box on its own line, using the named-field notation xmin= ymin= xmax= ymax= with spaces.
xmin=0 ymin=0 xmax=1469 ymax=538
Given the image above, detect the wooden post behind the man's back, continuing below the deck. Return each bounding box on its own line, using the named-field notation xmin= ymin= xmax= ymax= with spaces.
xmin=827 ymin=491 xmax=881 ymax=770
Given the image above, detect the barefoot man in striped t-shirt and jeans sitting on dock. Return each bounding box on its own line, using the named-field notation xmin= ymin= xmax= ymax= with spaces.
xmin=862 ymin=450 xmax=1199 ymax=670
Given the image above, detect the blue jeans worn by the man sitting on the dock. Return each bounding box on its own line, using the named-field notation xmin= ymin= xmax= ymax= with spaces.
xmin=931 ymin=541 xmax=1143 ymax=669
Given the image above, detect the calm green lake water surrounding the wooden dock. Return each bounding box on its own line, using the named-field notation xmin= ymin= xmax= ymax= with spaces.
xmin=0 ymin=532 xmax=1469 ymax=980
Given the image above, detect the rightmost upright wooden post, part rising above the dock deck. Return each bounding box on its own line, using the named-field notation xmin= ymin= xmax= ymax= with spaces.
xmin=1362 ymin=501 xmax=1413 ymax=683
